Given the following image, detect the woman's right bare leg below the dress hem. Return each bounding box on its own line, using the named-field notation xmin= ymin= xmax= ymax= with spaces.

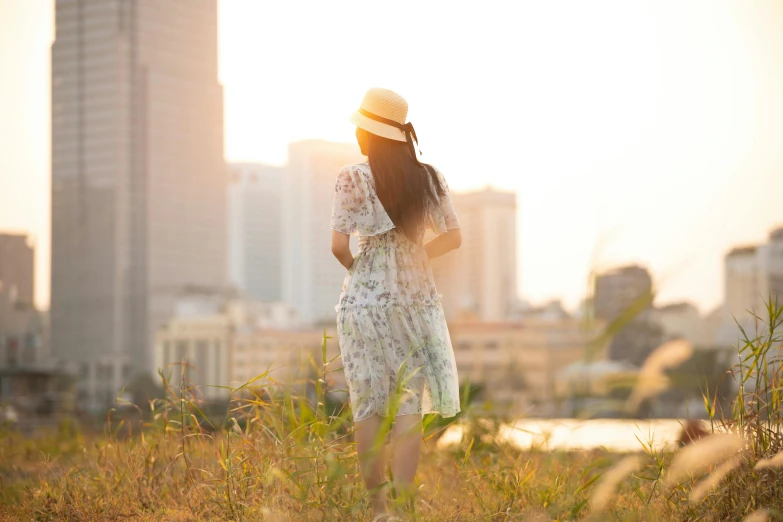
xmin=392 ymin=413 xmax=422 ymax=510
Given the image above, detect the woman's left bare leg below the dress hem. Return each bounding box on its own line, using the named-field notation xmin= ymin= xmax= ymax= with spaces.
xmin=354 ymin=414 xmax=387 ymax=516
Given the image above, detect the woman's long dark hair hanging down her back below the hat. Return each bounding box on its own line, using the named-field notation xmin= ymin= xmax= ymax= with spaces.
xmin=367 ymin=132 xmax=446 ymax=242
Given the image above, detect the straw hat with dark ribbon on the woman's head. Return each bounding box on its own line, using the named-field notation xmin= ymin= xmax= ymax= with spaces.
xmin=350 ymin=87 xmax=421 ymax=161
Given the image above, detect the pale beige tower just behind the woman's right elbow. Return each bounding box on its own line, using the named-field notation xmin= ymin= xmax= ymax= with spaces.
xmin=432 ymin=188 xmax=519 ymax=322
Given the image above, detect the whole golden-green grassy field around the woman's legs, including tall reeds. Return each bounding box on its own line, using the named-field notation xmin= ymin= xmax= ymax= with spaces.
xmin=0 ymin=298 xmax=783 ymax=521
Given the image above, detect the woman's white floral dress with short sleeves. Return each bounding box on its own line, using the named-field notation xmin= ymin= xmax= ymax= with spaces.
xmin=331 ymin=162 xmax=460 ymax=422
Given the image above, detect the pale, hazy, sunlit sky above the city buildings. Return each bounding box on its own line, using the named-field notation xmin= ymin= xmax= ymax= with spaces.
xmin=0 ymin=0 xmax=783 ymax=310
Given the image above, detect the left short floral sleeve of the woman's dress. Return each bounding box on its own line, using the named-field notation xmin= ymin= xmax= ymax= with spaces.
xmin=331 ymin=165 xmax=394 ymax=236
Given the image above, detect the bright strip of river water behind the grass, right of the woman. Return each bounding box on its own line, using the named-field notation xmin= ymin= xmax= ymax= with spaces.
xmin=438 ymin=419 xmax=709 ymax=452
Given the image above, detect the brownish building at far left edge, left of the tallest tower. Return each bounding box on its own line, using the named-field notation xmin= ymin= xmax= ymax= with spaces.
xmin=0 ymin=234 xmax=47 ymax=368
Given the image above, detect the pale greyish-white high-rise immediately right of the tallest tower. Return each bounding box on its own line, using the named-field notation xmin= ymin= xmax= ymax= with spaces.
xmin=228 ymin=163 xmax=283 ymax=302
